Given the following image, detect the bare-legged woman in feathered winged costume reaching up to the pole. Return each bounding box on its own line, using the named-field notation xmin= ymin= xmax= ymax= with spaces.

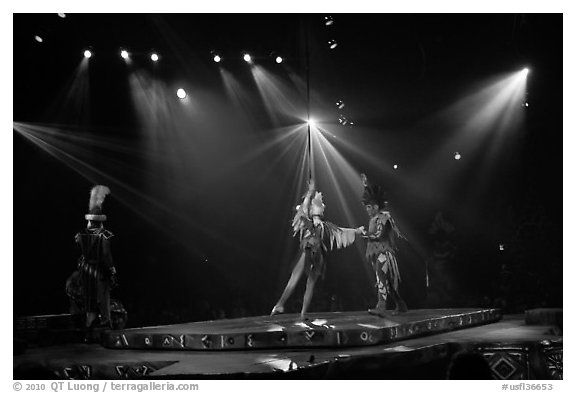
xmin=271 ymin=180 xmax=364 ymax=320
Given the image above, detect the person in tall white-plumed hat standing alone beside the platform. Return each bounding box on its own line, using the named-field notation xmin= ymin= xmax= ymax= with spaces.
xmin=75 ymin=185 xmax=117 ymax=327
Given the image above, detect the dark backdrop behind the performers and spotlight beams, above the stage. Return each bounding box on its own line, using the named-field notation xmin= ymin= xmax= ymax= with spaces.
xmin=13 ymin=14 xmax=562 ymax=326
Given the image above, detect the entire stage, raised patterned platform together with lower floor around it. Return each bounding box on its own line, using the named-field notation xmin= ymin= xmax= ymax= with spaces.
xmin=14 ymin=309 xmax=563 ymax=380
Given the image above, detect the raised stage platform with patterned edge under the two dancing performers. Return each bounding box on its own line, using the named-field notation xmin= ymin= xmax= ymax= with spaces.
xmin=102 ymin=309 xmax=502 ymax=351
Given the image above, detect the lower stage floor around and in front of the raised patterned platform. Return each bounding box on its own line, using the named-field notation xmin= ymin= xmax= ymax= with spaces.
xmin=14 ymin=315 xmax=561 ymax=379
